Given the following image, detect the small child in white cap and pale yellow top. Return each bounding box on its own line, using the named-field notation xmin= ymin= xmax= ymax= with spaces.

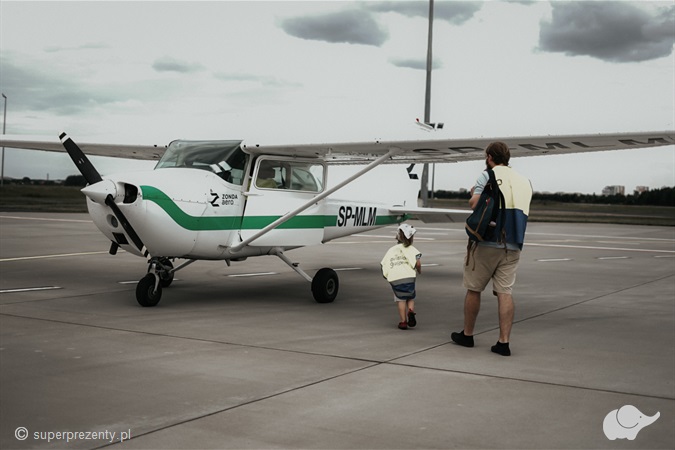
xmin=380 ymin=223 xmax=422 ymax=330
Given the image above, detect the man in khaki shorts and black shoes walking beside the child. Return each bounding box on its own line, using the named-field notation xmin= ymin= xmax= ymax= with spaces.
xmin=451 ymin=142 xmax=532 ymax=356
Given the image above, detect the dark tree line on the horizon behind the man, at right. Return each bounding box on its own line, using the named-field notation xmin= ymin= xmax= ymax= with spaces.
xmin=434 ymin=187 xmax=675 ymax=206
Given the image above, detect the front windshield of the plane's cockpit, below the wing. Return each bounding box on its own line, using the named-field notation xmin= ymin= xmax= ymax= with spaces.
xmin=155 ymin=141 xmax=247 ymax=186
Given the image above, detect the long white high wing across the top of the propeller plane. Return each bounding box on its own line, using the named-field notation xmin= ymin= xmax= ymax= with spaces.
xmin=0 ymin=130 xmax=675 ymax=164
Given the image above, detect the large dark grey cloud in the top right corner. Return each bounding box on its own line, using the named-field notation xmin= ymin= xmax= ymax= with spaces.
xmin=539 ymin=2 xmax=675 ymax=63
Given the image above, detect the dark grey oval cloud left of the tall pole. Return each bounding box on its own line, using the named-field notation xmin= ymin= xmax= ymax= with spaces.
xmin=281 ymin=10 xmax=389 ymax=47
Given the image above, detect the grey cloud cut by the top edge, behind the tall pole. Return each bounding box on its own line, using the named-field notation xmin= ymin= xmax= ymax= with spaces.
xmin=363 ymin=1 xmax=483 ymax=25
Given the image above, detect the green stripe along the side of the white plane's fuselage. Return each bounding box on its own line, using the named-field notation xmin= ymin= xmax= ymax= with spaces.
xmin=141 ymin=186 xmax=410 ymax=231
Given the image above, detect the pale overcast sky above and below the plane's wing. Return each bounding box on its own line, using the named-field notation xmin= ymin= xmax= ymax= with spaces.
xmin=0 ymin=0 xmax=675 ymax=194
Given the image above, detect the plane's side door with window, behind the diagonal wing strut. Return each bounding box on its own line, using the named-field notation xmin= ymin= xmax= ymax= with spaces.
xmin=241 ymin=157 xmax=326 ymax=247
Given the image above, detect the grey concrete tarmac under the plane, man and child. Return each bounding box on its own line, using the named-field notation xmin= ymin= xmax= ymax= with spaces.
xmin=0 ymin=213 xmax=675 ymax=449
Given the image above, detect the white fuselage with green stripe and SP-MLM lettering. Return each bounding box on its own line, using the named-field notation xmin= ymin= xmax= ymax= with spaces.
xmin=83 ymin=141 xmax=406 ymax=260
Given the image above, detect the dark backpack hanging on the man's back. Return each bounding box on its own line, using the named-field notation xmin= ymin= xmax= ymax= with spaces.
xmin=464 ymin=169 xmax=506 ymax=243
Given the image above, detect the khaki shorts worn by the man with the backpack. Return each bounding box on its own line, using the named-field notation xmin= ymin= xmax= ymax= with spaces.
xmin=464 ymin=245 xmax=520 ymax=294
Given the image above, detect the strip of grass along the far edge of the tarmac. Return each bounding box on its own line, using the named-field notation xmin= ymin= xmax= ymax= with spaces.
xmin=0 ymin=185 xmax=675 ymax=226
